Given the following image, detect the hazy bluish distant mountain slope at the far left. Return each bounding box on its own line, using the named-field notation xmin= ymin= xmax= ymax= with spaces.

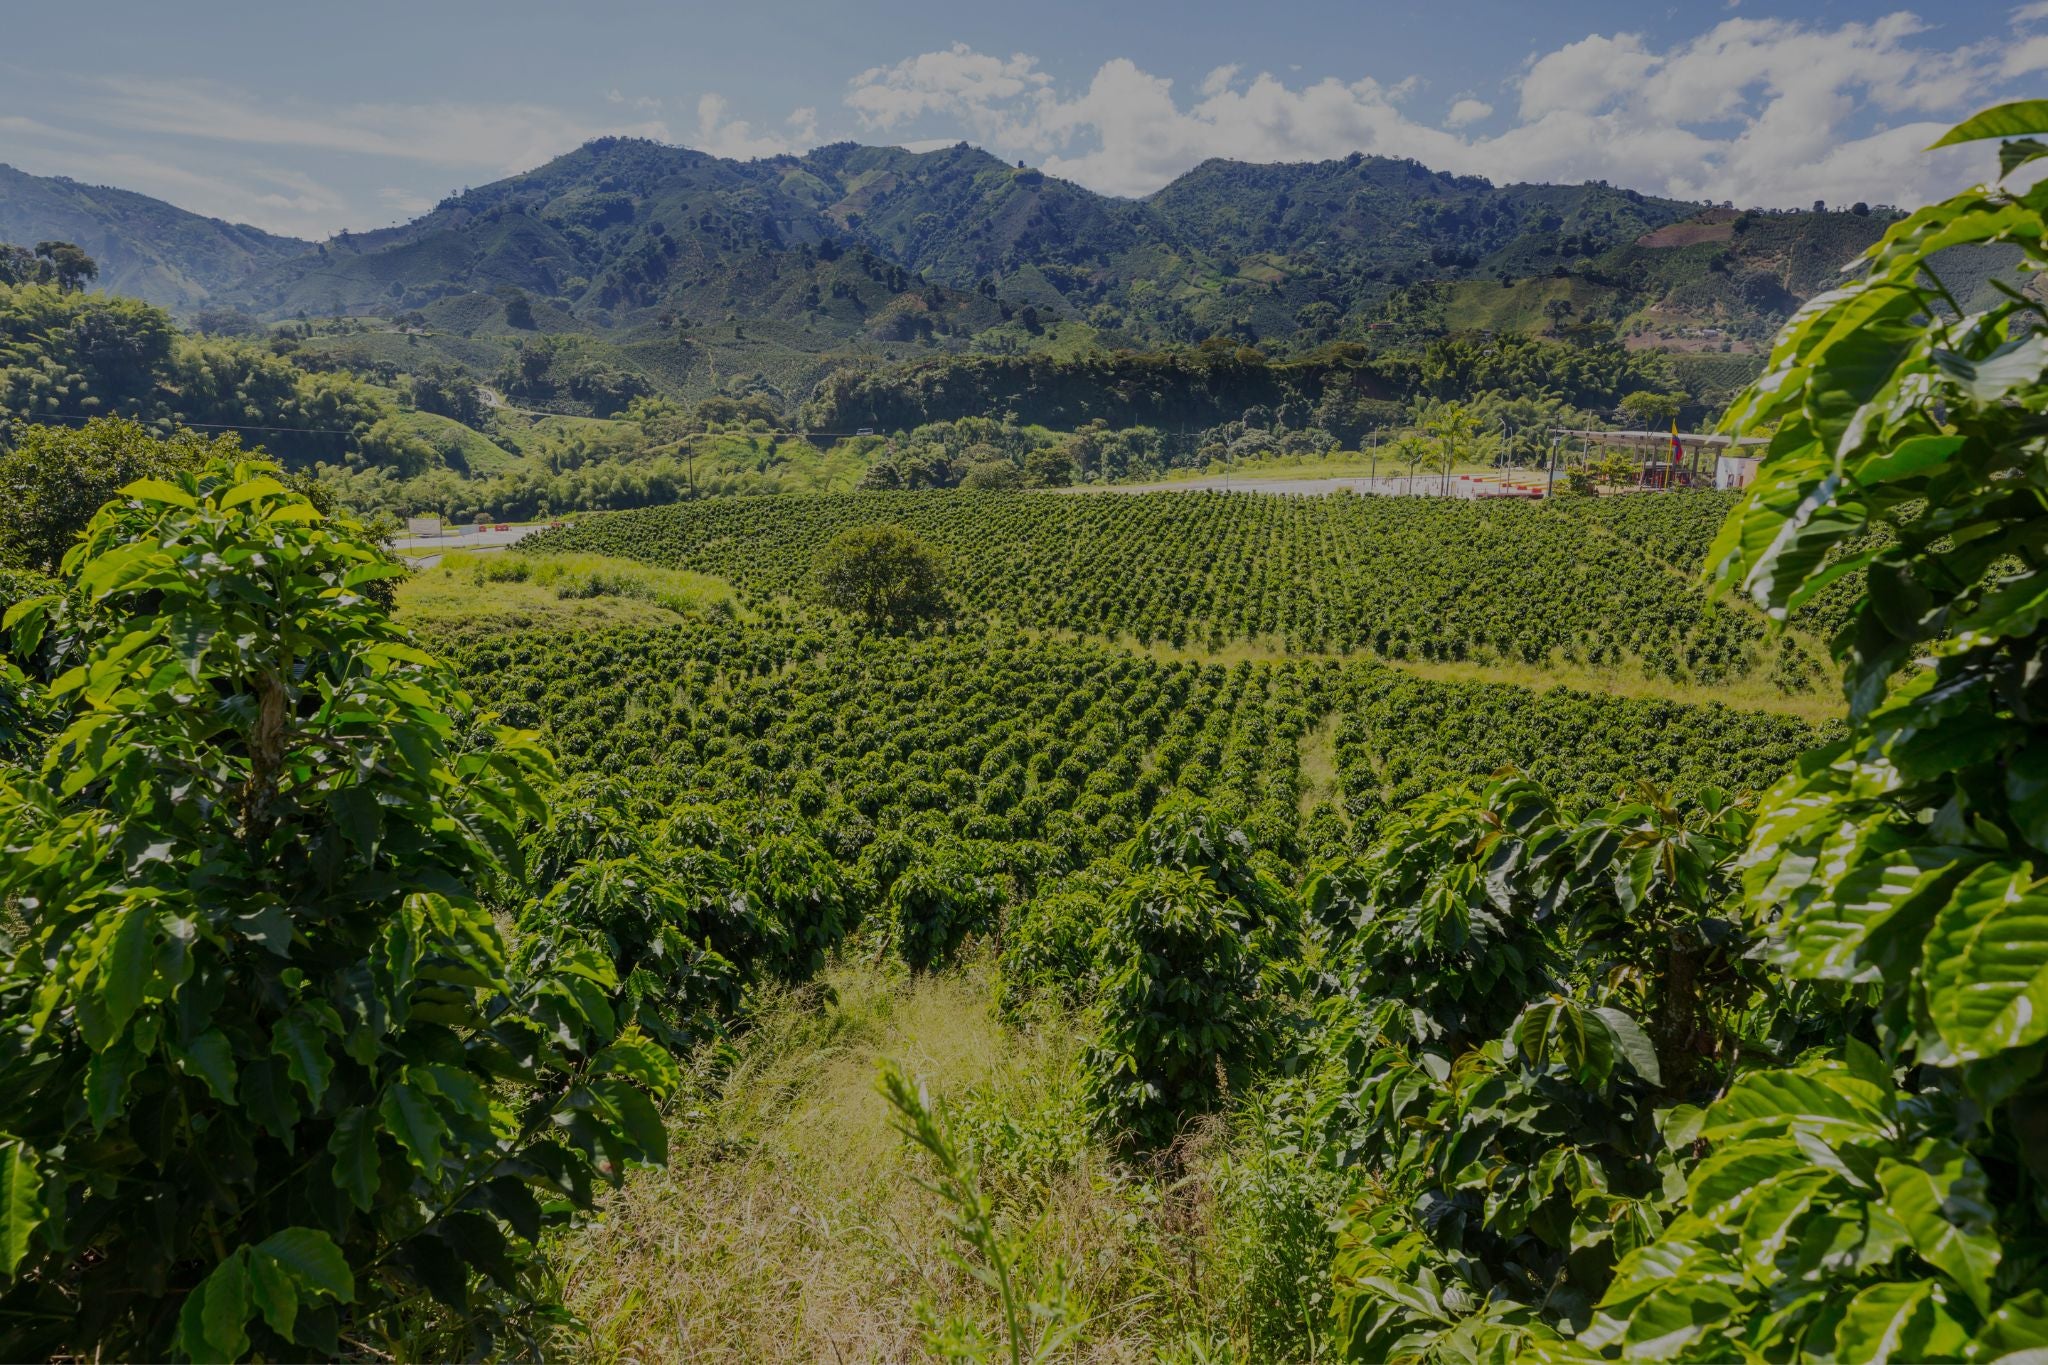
xmin=0 ymin=164 xmax=313 ymax=309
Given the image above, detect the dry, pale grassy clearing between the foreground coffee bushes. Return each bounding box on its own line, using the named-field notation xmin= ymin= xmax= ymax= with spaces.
xmin=559 ymin=960 xmax=1208 ymax=1363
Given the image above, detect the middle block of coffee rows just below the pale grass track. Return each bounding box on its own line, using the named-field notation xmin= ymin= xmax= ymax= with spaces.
xmin=436 ymin=622 xmax=1817 ymax=866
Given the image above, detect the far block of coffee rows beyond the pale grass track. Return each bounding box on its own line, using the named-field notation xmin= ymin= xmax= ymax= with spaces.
xmin=524 ymin=493 xmax=1817 ymax=690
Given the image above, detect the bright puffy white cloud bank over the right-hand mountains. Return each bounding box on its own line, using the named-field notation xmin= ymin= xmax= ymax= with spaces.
xmin=846 ymin=13 xmax=2007 ymax=205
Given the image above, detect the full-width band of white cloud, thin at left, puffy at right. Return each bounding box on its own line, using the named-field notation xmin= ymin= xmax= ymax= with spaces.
xmin=0 ymin=0 xmax=2023 ymax=235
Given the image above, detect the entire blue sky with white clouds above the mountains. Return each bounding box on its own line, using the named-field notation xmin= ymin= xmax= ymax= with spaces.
xmin=0 ymin=0 xmax=2023 ymax=235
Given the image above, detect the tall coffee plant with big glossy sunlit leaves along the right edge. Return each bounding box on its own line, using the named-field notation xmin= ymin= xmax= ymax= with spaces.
xmin=1583 ymin=106 xmax=2048 ymax=1359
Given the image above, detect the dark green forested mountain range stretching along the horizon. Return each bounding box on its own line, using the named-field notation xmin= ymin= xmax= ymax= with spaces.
xmin=0 ymin=137 xmax=1916 ymax=346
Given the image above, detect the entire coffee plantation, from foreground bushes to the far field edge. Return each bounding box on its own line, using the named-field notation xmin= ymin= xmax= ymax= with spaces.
xmin=0 ymin=102 xmax=2048 ymax=1365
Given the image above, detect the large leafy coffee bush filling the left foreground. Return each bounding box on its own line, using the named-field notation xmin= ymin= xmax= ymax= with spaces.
xmin=0 ymin=465 xmax=676 ymax=1359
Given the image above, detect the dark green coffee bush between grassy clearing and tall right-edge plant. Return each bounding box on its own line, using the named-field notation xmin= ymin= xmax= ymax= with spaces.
xmin=1296 ymin=778 xmax=1804 ymax=1359
